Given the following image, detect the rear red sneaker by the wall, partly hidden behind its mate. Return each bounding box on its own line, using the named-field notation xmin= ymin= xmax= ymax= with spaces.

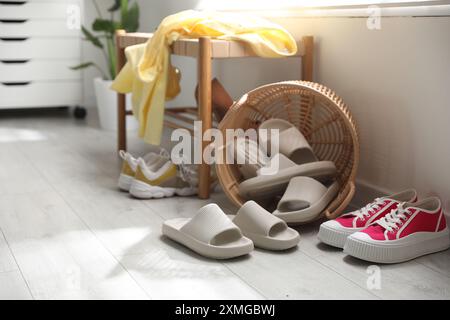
xmin=317 ymin=189 xmax=417 ymax=248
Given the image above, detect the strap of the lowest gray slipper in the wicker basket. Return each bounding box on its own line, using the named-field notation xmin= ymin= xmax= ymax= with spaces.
xmin=277 ymin=177 xmax=328 ymax=212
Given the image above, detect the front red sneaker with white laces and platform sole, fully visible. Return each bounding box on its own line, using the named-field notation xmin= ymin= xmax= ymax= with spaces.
xmin=344 ymin=197 xmax=450 ymax=263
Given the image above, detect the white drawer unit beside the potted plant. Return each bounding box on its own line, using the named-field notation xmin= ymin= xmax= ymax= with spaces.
xmin=0 ymin=0 xmax=82 ymax=114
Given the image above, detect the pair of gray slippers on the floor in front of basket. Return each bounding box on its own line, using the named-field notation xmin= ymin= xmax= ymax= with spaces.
xmin=162 ymin=201 xmax=300 ymax=259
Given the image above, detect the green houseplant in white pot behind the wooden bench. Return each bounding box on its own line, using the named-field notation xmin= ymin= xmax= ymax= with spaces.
xmin=72 ymin=0 xmax=139 ymax=131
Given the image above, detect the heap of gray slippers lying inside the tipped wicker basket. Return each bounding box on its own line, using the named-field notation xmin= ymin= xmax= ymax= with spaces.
xmin=233 ymin=119 xmax=339 ymax=224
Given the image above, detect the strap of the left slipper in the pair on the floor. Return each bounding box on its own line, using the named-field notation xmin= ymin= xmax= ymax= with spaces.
xmin=180 ymin=203 xmax=242 ymax=244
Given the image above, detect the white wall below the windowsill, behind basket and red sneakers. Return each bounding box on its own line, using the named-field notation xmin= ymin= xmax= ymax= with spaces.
xmin=253 ymin=17 xmax=450 ymax=211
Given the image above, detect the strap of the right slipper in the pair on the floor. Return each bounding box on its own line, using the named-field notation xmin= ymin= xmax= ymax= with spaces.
xmin=233 ymin=201 xmax=287 ymax=236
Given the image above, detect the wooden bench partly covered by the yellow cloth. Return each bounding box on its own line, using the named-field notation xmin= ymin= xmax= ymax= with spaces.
xmin=116 ymin=30 xmax=314 ymax=199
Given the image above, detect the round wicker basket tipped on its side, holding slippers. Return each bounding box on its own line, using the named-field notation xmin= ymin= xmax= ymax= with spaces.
xmin=216 ymin=81 xmax=359 ymax=219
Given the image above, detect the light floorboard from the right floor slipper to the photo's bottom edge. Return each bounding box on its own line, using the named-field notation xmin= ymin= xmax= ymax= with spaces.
xmin=227 ymin=249 xmax=376 ymax=299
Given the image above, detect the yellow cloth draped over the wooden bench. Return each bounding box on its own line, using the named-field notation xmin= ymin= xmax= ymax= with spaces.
xmin=111 ymin=10 xmax=297 ymax=144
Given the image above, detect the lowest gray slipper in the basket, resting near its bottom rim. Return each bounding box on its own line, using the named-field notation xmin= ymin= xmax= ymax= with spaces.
xmin=273 ymin=177 xmax=339 ymax=224
